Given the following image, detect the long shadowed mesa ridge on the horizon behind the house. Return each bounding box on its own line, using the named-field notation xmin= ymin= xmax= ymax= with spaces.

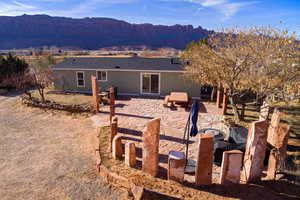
xmin=0 ymin=15 xmax=211 ymax=49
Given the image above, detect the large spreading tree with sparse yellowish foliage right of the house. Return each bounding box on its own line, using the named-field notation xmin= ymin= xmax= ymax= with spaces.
xmin=182 ymin=27 xmax=300 ymax=121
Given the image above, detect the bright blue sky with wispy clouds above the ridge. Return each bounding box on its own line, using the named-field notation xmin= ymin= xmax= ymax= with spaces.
xmin=0 ymin=0 xmax=300 ymax=35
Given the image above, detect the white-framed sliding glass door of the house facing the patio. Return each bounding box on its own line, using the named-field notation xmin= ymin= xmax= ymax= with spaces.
xmin=141 ymin=73 xmax=160 ymax=94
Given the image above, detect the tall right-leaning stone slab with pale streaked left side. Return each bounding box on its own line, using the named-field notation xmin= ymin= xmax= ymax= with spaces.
xmin=242 ymin=121 xmax=269 ymax=183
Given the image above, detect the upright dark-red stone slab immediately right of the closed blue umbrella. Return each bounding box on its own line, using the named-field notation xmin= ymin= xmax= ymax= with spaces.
xmin=195 ymin=133 xmax=214 ymax=185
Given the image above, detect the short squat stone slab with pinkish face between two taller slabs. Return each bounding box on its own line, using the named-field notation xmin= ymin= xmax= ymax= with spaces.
xmin=219 ymin=150 xmax=243 ymax=185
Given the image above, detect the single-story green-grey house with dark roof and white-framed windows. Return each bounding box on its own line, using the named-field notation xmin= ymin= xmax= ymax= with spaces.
xmin=52 ymin=57 xmax=200 ymax=97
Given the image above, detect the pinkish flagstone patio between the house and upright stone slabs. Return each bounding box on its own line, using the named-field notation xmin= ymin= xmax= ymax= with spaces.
xmin=91 ymin=97 xmax=228 ymax=183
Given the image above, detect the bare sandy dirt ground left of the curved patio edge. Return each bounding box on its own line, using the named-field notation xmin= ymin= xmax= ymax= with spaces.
xmin=0 ymin=96 xmax=119 ymax=199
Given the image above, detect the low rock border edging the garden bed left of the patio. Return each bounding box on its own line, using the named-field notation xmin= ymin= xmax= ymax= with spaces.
xmin=21 ymin=96 xmax=92 ymax=113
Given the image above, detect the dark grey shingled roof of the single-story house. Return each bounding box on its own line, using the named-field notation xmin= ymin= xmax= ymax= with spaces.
xmin=52 ymin=57 xmax=184 ymax=72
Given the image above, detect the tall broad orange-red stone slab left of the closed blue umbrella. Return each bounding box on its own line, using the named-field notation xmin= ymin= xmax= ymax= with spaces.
xmin=142 ymin=118 xmax=160 ymax=177
